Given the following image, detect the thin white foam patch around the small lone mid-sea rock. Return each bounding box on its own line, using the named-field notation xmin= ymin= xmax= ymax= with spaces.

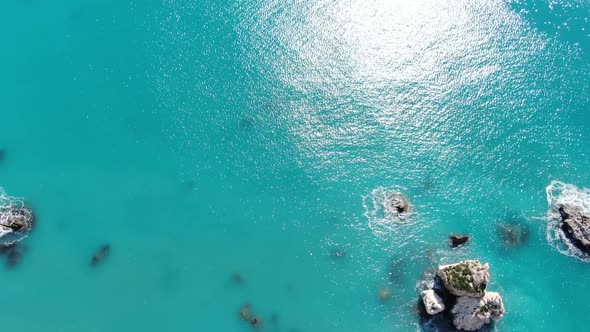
xmin=363 ymin=187 xmax=413 ymax=236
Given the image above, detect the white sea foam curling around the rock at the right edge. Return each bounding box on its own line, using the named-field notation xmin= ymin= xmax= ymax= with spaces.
xmin=545 ymin=181 xmax=590 ymax=262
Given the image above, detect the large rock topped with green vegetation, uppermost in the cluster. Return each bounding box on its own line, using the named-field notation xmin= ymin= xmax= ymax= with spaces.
xmin=437 ymin=260 xmax=490 ymax=297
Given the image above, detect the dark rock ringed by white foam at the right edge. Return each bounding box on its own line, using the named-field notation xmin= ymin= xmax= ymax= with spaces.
xmin=558 ymin=204 xmax=590 ymax=254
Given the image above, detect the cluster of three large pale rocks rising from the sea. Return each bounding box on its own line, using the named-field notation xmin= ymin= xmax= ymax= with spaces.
xmin=420 ymin=260 xmax=506 ymax=331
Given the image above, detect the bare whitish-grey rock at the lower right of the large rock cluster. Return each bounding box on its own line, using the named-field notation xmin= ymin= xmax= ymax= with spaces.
xmin=451 ymin=292 xmax=506 ymax=331
